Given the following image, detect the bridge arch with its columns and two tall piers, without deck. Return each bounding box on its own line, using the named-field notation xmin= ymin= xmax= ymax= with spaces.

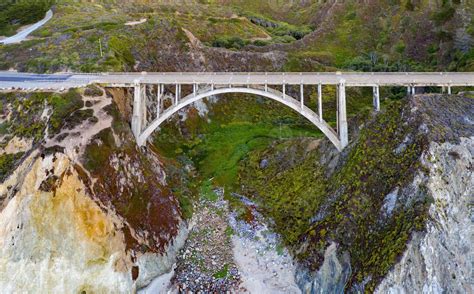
xmin=132 ymin=81 xmax=356 ymax=151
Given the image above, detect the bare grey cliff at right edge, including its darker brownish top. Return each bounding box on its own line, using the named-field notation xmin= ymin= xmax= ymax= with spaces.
xmin=377 ymin=96 xmax=474 ymax=293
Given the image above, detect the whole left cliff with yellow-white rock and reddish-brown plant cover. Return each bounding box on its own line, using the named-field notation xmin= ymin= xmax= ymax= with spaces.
xmin=0 ymin=88 xmax=187 ymax=293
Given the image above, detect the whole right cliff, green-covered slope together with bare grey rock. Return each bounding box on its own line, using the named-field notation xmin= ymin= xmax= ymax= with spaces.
xmin=240 ymin=94 xmax=474 ymax=293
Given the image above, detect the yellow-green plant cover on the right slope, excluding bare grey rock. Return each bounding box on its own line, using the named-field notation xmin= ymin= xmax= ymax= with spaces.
xmin=239 ymin=101 xmax=429 ymax=292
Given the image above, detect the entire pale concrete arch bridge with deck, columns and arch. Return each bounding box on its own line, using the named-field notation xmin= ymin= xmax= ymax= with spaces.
xmin=0 ymin=72 xmax=474 ymax=150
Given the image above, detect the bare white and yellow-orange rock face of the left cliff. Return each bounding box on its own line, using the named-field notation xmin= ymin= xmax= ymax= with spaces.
xmin=0 ymin=154 xmax=133 ymax=293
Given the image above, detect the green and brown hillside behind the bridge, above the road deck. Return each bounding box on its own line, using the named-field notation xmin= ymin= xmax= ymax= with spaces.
xmin=0 ymin=0 xmax=474 ymax=72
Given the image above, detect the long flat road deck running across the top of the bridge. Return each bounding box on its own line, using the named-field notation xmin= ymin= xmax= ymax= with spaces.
xmin=0 ymin=71 xmax=474 ymax=89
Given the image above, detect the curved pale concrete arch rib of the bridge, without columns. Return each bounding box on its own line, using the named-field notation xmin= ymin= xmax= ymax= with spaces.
xmin=137 ymin=87 xmax=343 ymax=150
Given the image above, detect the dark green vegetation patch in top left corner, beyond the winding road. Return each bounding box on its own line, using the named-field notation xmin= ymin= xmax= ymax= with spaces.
xmin=0 ymin=0 xmax=55 ymax=36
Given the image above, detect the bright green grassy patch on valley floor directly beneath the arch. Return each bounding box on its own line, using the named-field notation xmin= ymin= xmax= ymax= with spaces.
xmin=154 ymin=97 xmax=321 ymax=199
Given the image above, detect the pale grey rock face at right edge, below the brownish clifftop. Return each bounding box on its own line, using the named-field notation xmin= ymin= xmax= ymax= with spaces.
xmin=376 ymin=137 xmax=474 ymax=293
